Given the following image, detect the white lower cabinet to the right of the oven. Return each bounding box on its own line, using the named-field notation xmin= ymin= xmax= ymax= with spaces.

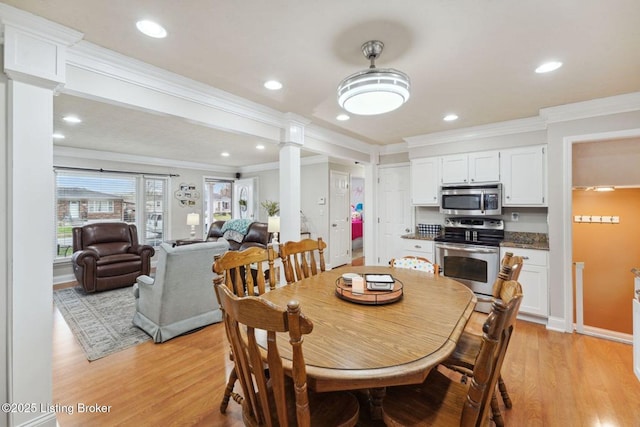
xmin=500 ymin=247 xmax=549 ymax=318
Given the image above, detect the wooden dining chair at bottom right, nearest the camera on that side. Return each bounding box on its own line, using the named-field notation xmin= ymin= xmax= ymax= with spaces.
xmin=382 ymin=295 xmax=522 ymax=427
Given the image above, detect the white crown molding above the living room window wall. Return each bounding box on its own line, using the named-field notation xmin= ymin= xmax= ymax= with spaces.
xmin=53 ymin=145 xmax=238 ymax=174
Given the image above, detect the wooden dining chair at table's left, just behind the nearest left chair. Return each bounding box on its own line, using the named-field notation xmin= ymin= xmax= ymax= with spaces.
xmin=213 ymin=245 xmax=275 ymax=414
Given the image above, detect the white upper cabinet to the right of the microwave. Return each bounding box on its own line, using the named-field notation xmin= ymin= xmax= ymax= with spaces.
xmin=500 ymin=145 xmax=547 ymax=206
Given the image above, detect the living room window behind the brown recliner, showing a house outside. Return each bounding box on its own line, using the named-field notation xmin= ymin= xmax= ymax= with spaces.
xmin=55 ymin=169 xmax=168 ymax=258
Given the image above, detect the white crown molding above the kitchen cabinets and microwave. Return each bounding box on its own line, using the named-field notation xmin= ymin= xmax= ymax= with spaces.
xmin=404 ymin=117 xmax=547 ymax=149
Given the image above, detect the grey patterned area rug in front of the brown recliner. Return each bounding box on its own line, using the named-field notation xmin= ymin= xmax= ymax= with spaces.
xmin=53 ymin=286 xmax=151 ymax=361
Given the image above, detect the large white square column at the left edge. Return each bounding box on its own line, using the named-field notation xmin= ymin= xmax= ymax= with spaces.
xmin=0 ymin=5 xmax=82 ymax=426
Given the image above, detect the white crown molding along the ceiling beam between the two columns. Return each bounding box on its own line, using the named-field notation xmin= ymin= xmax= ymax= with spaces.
xmin=67 ymin=41 xmax=287 ymax=128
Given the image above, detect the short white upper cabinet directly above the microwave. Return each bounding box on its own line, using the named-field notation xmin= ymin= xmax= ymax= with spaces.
xmin=442 ymin=151 xmax=500 ymax=184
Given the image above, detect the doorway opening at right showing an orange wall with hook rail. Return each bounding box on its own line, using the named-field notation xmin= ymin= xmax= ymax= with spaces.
xmin=565 ymin=130 xmax=640 ymax=342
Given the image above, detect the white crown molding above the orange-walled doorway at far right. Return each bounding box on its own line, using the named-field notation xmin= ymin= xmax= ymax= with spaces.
xmin=540 ymin=92 xmax=640 ymax=123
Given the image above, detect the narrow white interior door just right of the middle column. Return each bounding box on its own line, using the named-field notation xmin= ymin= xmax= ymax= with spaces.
xmin=329 ymin=170 xmax=351 ymax=268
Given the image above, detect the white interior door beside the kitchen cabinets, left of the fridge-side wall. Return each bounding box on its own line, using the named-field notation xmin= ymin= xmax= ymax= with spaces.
xmin=377 ymin=166 xmax=413 ymax=265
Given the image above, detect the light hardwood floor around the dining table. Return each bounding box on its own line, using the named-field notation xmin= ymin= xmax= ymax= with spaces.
xmin=53 ymin=302 xmax=640 ymax=427
